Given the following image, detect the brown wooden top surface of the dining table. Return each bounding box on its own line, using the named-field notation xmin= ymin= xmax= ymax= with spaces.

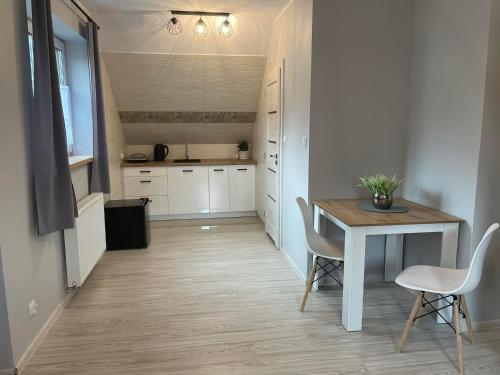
xmin=312 ymin=199 xmax=464 ymax=227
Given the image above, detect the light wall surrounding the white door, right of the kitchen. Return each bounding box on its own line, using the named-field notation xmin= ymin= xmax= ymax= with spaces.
xmin=252 ymin=0 xmax=312 ymax=277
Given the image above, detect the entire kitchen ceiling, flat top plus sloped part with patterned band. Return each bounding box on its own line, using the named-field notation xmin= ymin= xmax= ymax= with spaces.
xmin=82 ymin=0 xmax=288 ymax=144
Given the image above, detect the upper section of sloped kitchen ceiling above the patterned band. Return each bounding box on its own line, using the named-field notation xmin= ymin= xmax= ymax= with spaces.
xmin=104 ymin=53 xmax=266 ymax=112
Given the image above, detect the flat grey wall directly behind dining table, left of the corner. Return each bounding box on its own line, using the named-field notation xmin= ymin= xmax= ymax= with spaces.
xmin=309 ymin=0 xmax=411 ymax=279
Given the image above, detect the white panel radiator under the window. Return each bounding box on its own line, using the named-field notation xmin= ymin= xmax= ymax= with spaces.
xmin=64 ymin=193 xmax=106 ymax=288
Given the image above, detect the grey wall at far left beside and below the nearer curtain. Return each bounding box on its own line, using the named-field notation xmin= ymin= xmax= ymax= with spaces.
xmin=0 ymin=0 xmax=71 ymax=362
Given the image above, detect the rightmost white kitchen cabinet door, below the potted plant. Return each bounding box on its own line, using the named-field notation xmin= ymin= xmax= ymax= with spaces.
xmin=229 ymin=165 xmax=255 ymax=212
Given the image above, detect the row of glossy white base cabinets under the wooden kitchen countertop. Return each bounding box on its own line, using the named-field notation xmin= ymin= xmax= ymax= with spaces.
xmin=123 ymin=165 xmax=255 ymax=219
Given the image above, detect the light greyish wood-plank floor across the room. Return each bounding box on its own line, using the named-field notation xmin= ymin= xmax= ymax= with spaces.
xmin=23 ymin=219 xmax=500 ymax=375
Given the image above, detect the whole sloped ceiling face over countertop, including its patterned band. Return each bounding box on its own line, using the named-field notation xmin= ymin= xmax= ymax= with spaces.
xmin=104 ymin=53 xmax=265 ymax=144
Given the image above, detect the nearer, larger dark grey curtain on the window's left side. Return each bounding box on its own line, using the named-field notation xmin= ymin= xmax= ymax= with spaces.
xmin=31 ymin=0 xmax=76 ymax=235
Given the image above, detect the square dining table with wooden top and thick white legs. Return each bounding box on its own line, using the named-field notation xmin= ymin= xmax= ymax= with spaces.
xmin=312 ymin=199 xmax=463 ymax=331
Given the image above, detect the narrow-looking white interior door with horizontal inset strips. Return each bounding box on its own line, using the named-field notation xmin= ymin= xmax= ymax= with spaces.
xmin=265 ymin=69 xmax=281 ymax=248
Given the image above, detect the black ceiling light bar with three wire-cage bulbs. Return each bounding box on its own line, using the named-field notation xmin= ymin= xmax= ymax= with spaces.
xmin=167 ymin=10 xmax=233 ymax=39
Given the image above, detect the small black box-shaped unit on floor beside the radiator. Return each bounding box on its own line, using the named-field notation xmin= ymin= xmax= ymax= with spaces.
xmin=104 ymin=198 xmax=151 ymax=250
